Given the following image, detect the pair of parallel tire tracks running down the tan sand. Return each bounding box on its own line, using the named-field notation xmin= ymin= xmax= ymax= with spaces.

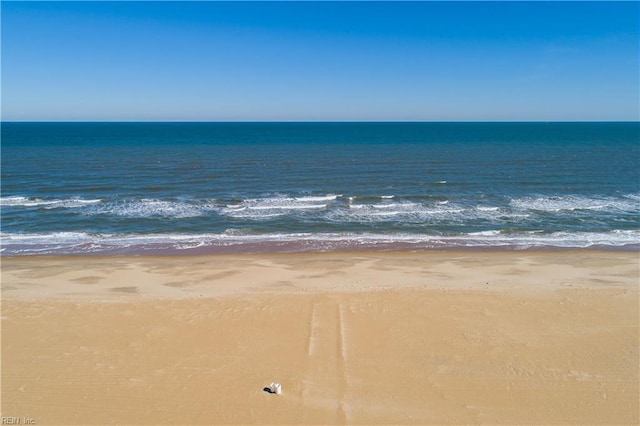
xmin=302 ymin=297 xmax=348 ymax=424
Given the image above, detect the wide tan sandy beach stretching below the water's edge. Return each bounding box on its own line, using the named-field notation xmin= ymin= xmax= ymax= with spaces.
xmin=1 ymin=251 xmax=640 ymax=425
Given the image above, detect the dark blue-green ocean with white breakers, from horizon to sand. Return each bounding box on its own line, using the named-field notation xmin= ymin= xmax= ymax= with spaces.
xmin=0 ymin=122 xmax=640 ymax=256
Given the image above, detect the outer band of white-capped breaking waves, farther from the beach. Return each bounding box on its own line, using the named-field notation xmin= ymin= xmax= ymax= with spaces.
xmin=0 ymin=193 xmax=640 ymax=226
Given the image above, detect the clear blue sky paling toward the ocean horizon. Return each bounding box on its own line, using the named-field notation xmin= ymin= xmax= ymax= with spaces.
xmin=1 ymin=1 xmax=640 ymax=121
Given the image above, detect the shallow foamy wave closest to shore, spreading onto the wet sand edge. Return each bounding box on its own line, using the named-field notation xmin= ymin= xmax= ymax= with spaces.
xmin=0 ymin=229 xmax=640 ymax=256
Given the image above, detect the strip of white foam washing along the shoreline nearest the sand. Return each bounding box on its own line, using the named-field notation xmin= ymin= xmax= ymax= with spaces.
xmin=0 ymin=230 xmax=640 ymax=254
